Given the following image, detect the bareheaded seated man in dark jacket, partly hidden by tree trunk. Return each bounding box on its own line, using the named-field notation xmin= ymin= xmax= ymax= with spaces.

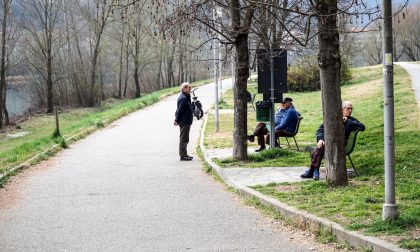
xmin=300 ymin=101 xmax=365 ymax=180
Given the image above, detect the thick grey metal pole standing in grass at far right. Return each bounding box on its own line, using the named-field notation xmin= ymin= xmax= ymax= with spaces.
xmin=382 ymin=0 xmax=398 ymax=220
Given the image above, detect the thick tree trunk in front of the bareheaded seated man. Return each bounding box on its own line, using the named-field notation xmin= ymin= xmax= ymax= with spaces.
xmin=316 ymin=0 xmax=347 ymax=186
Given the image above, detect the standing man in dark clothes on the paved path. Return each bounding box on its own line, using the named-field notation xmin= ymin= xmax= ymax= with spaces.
xmin=174 ymin=82 xmax=193 ymax=161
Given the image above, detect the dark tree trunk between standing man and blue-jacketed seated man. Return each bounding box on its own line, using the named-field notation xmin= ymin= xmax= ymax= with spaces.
xmin=233 ymin=34 xmax=249 ymax=160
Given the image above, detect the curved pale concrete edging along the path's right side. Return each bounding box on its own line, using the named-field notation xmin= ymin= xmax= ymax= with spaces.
xmin=200 ymin=113 xmax=409 ymax=252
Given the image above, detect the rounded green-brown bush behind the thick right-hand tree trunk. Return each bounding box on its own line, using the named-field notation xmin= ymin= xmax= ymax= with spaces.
xmin=287 ymin=56 xmax=351 ymax=92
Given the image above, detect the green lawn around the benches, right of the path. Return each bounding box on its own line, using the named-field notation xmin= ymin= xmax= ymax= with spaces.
xmin=203 ymin=66 xmax=420 ymax=251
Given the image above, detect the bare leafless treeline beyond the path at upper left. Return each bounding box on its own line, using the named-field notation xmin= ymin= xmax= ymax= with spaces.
xmin=0 ymin=0 xmax=210 ymax=128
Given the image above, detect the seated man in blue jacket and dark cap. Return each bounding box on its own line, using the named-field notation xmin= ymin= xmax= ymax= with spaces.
xmin=248 ymin=97 xmax=299 ymax=152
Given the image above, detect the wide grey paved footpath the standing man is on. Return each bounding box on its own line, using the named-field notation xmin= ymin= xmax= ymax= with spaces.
xmin=0 ymin=79 xmax=322 ymax=251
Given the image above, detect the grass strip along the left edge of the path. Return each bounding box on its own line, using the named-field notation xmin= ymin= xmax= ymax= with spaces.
xmin=0 ymin=80 xmax=209 ymax=177
